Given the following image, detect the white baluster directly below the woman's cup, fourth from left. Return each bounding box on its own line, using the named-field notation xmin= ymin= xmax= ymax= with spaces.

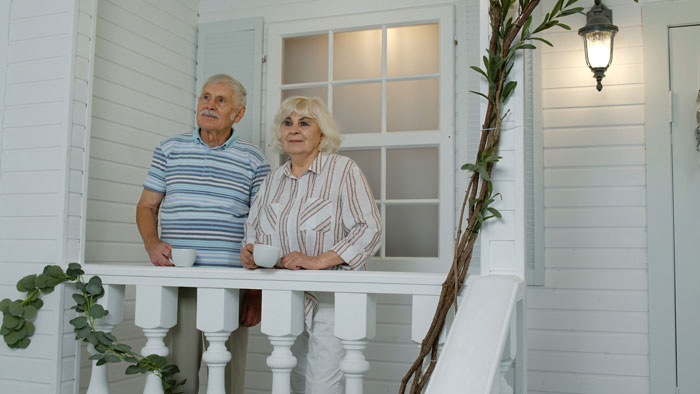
xmin=261 ymin=290 xmax=304 ymax=394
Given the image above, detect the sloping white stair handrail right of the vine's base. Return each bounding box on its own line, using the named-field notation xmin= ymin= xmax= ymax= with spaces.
xmin=426 ymin=275 xmax=522 ymax=394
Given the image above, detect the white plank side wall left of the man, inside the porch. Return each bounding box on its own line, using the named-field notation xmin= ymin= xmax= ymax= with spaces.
xmin=80 ymin=0 xmax=199 ymax=393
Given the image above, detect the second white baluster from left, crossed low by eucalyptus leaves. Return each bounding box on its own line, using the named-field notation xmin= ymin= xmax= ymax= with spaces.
xmin=134 ymin=286 xmax=177 ymax=394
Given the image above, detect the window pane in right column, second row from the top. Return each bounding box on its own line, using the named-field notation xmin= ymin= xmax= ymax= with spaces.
xmin=386 ymin=79 xmax=440 ymax=131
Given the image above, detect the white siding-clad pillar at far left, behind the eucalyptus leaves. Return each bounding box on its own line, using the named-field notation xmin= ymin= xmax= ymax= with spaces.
xmin=0 ymin=0 xmax=95 ymax=393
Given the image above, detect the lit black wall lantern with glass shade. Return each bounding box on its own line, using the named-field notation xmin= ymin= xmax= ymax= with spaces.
xmin=578 ymin=0 xmax=618 ymax=91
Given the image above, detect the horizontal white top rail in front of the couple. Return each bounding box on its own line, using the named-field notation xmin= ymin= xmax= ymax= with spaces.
xmin=84 ymin=264 xmax=445 ymax=295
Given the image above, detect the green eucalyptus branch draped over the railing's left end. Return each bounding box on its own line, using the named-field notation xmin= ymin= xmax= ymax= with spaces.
xmin=0 ymin=263 xmax=185 ymax=394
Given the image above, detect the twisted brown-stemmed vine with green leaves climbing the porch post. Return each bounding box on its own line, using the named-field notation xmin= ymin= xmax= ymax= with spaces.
xmin=399 ymin=0 xmax=616 ymax=394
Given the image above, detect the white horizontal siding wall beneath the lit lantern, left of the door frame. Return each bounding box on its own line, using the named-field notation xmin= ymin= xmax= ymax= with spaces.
xmin=527 ymin=0 xmax=649 ymax=394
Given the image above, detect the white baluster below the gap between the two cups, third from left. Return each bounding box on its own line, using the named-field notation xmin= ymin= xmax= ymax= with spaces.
xmin=197 ymin=288 xmax=239 ymax=394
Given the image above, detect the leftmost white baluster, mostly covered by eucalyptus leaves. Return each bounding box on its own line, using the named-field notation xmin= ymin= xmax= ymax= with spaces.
xmin=87 ymin=285 xmax=124 ymax=394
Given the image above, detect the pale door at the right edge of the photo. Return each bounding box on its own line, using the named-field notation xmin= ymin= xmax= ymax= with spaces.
xmin=669 ymin=25 xmax=700 ymax=394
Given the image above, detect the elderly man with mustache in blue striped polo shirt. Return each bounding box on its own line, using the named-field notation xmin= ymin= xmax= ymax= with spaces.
xmin=136 ymin=74 xmax=270 ymax=394
